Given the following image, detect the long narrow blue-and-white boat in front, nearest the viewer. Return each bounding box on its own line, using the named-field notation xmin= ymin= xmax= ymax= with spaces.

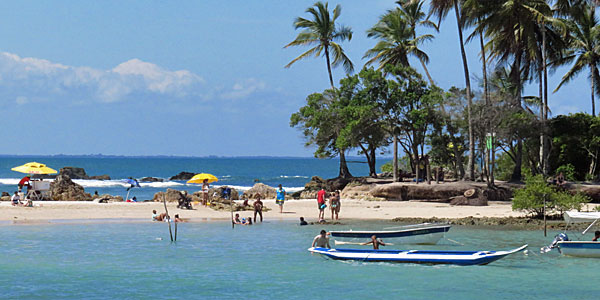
xmin=308 ymin=245 xmax=527 ymax=266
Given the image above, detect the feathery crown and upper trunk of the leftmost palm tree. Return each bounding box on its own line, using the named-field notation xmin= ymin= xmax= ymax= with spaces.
xmin=285 ymin=2 xmax=354 ymax=88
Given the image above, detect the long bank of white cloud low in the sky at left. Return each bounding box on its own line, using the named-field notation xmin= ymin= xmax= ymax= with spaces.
xmin=0 ymin=52 xmax=211 ymax=104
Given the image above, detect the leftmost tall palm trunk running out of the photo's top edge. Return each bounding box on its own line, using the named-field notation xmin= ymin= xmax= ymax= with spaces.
xmin=430 ymin=0 xmax=475 ymax=180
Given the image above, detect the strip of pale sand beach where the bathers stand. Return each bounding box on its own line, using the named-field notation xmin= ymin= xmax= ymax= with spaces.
xmin=0 ymin=199 xmax=524 ymax=224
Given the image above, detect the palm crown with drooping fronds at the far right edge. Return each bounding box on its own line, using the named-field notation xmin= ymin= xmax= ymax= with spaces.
xmin=554 ymin=5 xmax=600 ymax=116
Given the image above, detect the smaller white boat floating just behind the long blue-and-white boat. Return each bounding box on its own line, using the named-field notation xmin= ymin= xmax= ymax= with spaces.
xmin=330 ymin=223 xmax=452 ymax=244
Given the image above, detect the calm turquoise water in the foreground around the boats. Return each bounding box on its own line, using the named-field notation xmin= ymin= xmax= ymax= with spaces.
xmin=0 ymin=222 xmax=600 ymax=299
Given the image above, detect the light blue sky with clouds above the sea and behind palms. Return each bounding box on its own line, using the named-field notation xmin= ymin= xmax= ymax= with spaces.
xmin=0 ymin=0 xmax=591 ymax=157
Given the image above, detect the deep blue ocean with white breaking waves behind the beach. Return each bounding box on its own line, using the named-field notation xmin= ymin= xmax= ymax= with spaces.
xmin=0 ymin=156 xmax=389 ymax=200
